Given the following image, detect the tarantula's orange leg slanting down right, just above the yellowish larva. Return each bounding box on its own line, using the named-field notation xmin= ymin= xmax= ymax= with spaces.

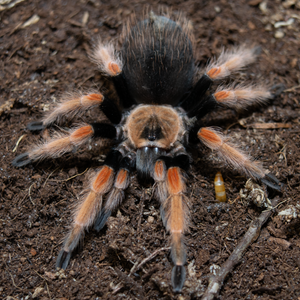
xmin=197 ymin=127 xmax=281 ymax=190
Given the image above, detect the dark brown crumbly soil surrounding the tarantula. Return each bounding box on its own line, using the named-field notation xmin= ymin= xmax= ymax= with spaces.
xmin=0 ymin=0 xmax=300 ymax=300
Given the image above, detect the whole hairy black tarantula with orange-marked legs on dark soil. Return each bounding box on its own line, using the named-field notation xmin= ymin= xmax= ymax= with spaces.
xmin=13 ymin=12 xmax=280 ymax=291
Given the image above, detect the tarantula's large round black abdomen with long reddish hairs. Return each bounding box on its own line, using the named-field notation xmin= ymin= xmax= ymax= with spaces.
xmin=122 ymin=13 xmax=194 ymax=105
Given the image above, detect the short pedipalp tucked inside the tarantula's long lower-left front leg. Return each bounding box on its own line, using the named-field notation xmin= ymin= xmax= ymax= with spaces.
xmin=94 ymin=156 xmax=135 ymax=231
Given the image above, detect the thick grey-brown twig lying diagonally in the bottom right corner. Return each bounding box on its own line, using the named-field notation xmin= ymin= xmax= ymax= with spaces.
xmin=202 ymin=197 xmax=279 ymax=300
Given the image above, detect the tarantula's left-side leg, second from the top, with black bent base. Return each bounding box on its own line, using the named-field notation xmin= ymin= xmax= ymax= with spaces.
xmin=27 ymin=93 xmax=122 ymax=131
